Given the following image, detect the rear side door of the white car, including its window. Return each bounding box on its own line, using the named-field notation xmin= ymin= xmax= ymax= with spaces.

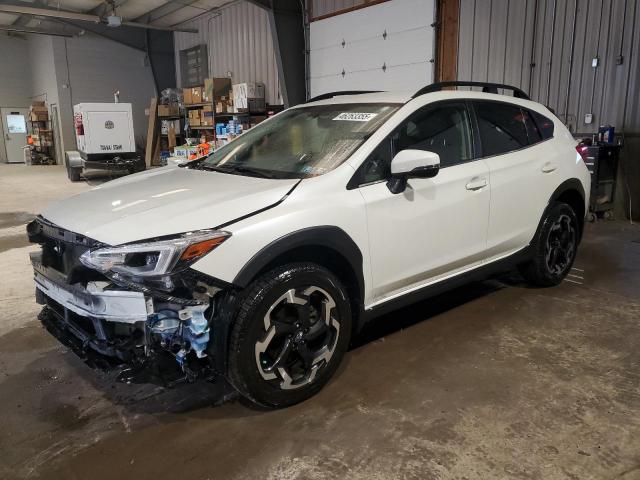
xmin=473 ymin=100 xmax=558 ymax=261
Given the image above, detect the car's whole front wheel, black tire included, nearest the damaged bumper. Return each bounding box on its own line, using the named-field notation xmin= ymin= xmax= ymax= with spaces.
xmin=228 ymin=263 xmax=351 ymax=408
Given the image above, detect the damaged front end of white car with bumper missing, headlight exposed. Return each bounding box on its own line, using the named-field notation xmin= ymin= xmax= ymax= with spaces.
xmin=27 ymin=217 xmax=232 ymax=385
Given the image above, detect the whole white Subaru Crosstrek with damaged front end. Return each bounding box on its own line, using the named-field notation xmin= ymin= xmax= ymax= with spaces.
xmin=28 ymin=82 xmax=590 ymax=407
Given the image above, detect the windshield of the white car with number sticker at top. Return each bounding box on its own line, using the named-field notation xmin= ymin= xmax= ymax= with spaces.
xmin=195 ymin=103 xmax=398 ymax=178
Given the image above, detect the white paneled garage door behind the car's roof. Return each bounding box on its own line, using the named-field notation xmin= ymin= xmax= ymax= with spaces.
xmin=309 ymin=0 xmax=435 ymax=97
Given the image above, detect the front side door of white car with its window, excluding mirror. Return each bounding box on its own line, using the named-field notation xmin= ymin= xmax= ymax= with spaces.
xmin=354 ymin=101 xmax=490 ymax=304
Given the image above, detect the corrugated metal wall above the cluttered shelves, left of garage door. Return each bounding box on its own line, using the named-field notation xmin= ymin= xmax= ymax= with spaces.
xmin=175 ymin=1 xmax=282 ymax=104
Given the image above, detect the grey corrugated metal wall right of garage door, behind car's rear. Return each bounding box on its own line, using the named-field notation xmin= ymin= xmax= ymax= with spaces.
xmin=458 ymin=0 xmax=640 ymax=133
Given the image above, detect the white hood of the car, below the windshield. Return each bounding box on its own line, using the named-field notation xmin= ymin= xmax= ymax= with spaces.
xmin=42 ymin=167 xmax=299 ymax=245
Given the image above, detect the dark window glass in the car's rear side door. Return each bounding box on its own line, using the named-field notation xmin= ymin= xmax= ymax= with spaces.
xmin=474 ymin=102 xmax=529 ymax=157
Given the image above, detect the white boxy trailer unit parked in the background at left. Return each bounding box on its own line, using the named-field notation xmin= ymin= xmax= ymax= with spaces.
xmin=66 ymin=103 xmax=145 ymax=181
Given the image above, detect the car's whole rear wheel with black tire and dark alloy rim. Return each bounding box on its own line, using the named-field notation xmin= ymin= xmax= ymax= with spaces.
xmin=518 ymin=202 xmax=580 ymax=287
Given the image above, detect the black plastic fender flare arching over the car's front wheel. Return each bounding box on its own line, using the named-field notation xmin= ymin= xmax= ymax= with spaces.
xmin=233 ymin=225 xmax=364 ymax=298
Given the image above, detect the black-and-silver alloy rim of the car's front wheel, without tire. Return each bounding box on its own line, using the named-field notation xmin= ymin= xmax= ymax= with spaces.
xmin=255 ymin=286 xmax=340 ymax=390
